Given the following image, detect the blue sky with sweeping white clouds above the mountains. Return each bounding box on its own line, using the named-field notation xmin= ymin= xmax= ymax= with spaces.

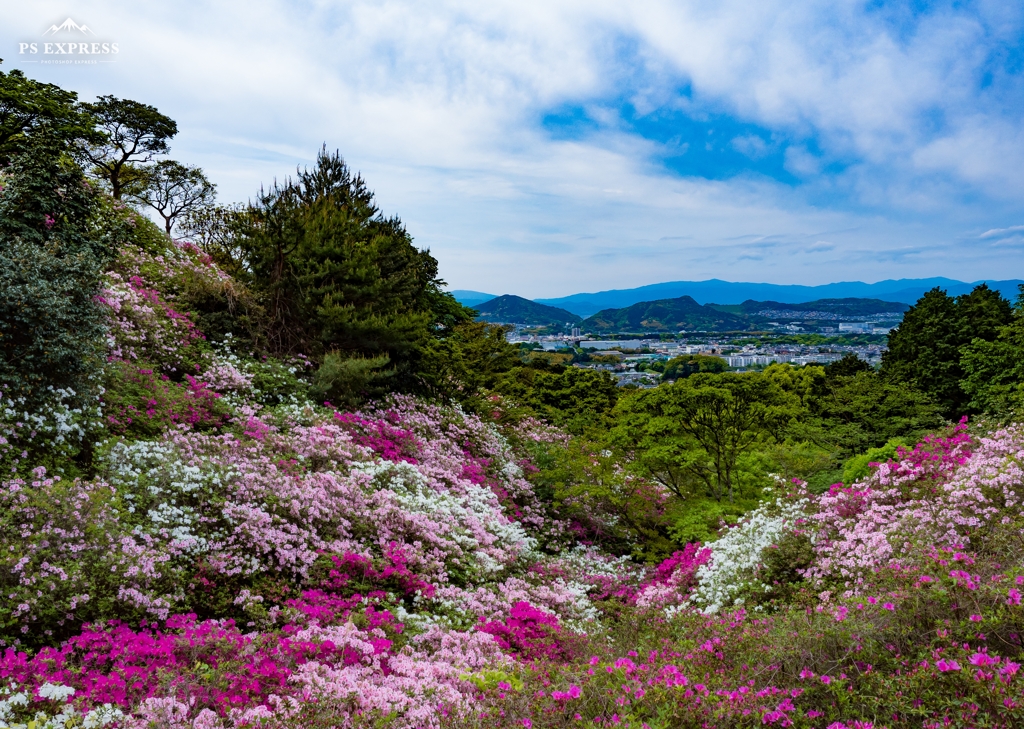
xmin=0 ymin=0 xmax=1024 ymax=298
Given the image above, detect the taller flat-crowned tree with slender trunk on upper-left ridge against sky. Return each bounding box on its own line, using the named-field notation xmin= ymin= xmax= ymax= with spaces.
xmin=82 ymin=96 xmax=178 ymax=200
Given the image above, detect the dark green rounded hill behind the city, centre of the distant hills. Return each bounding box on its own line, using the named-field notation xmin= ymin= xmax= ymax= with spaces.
xmin=584 ymin=296 xmax=749 ymax=332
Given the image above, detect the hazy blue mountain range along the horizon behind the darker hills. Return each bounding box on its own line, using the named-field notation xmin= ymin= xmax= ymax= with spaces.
xmin=452 ymin=276 xmax=1024 ymax=316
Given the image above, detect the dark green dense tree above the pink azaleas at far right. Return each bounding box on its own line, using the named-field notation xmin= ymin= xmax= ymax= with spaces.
xmin=882 ymin=284 xmax=1012 ymax=418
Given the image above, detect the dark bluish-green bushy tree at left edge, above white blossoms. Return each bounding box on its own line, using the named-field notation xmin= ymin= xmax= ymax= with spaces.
xmin=0 ymin=138 xmax=112 ymax=403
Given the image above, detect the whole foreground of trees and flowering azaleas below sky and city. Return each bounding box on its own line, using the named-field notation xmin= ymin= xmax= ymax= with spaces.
xmin=6 ymin=65 xmax=1024 ymax=729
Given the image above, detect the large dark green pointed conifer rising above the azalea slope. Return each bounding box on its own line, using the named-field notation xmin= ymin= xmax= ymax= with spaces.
xmin=231 ymin=149 xmax=462 ymax=401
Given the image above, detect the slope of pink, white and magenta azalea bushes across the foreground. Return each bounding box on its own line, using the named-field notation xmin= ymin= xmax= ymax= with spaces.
xmin=6 ymin=236 xmax=1024 ymax=729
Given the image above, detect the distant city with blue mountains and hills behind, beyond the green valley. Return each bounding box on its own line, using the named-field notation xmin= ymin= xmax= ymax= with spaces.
xmin=453 ymin=278 xmax=1024 ymax=388
